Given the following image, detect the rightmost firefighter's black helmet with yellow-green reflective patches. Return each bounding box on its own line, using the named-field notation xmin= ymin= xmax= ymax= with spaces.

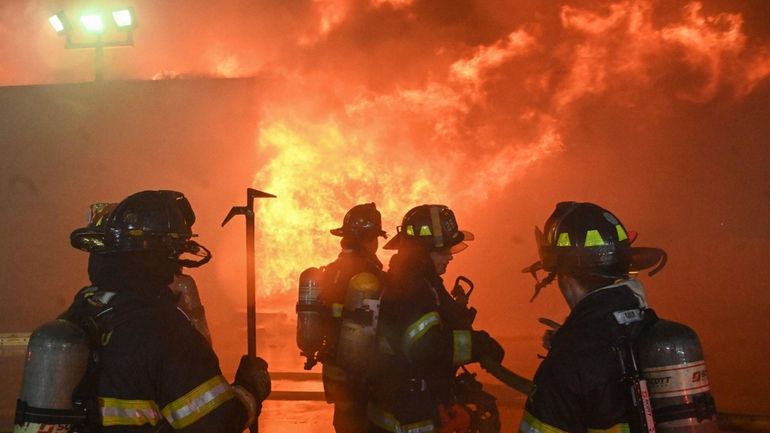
xmin=524 ymin=201 xmax=666 ymax=286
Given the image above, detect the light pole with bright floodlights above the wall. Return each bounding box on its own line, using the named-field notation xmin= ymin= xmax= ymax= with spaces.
xmin=48 ymin=8 xmax=136 ymax=81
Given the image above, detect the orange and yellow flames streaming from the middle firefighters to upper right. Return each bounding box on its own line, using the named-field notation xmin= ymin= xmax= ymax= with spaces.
xmin=243 ymin=0 xmax=770 ymax=293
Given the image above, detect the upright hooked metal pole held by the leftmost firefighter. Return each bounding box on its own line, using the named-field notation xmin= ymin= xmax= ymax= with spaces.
xmin=222 ymin=188 xmax=275 ymax=433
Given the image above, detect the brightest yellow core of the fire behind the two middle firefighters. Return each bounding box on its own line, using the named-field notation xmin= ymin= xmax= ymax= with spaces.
xmin=254 ymin=117 xmax=446 ymax=293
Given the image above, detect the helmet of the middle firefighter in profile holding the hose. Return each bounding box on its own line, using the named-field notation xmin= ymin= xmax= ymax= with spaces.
xmin=382 ymin=204 xmax=474 ymax=254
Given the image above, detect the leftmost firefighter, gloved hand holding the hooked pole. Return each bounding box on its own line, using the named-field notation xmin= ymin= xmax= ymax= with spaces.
xmin=33 ymin=190 xmax=270 ymax=433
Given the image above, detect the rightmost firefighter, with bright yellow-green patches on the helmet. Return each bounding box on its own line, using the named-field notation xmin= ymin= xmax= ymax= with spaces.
xmin=519 ymin=202 xmax=665 ymax=433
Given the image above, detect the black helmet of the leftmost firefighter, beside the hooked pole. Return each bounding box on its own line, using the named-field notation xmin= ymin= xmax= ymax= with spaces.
xmin=70 ymin=190 xmax=211 ymax=267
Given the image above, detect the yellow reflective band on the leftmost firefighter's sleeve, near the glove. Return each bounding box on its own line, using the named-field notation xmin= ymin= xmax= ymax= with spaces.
xmin=161 ymin=375 xmax=235 ymax=429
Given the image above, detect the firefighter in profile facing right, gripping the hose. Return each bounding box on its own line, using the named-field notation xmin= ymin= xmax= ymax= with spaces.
xmin=368 ymin=204 xmax=504 ymax=433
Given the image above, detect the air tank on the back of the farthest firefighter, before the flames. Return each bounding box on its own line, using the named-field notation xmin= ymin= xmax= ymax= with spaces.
xmin=297 ymin=268 xmax=324 ymax=370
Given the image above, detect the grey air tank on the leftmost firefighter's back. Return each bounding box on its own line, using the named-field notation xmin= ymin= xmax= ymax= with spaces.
xmin=13 ymin=319 xmax=91 ymax=433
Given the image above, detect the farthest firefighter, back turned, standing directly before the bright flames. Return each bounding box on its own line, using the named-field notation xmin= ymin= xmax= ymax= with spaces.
xmin=319 ymin=203 xmax=387 ymax=433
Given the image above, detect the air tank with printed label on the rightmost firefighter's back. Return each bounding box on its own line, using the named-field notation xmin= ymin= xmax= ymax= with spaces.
xmin=637 ymin=320 xmax=718 ymax=433
